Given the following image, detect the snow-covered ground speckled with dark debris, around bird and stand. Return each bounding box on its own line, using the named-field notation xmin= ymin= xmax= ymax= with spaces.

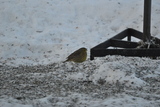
xmin=0 ymin=0 xmax=160 ymax=107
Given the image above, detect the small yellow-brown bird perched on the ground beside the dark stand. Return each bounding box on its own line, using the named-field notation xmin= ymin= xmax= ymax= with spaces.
xmin=64 ymin=47 xmax=87 ymax=63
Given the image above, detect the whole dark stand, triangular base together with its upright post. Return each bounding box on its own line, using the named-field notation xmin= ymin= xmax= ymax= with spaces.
xmin=90 ymin=0 xmax=160 ymax=60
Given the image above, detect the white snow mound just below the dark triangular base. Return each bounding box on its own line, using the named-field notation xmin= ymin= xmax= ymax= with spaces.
xmin=90 ymin=62 xmax=146 ymax=86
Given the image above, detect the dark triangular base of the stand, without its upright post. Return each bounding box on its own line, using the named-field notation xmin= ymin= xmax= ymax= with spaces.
xmin=90 ymin=28 xmax=160 ymax=60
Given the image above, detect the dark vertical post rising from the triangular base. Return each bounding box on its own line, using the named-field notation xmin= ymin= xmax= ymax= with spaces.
xmin=143 ymin=0 xmax=151 ymax=42
